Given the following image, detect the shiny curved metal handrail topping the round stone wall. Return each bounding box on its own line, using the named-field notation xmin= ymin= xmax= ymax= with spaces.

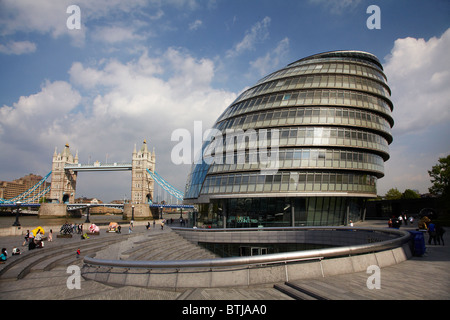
xmin=84 ymin=227 xmax=411 ymax=269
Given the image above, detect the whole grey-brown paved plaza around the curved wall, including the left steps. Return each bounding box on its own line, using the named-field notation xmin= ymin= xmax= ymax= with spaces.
xmin=0 ymin=221 xmax=450 ymax=301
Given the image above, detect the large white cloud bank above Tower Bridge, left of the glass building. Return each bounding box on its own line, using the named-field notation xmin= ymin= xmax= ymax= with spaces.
xmin=0 ymin=48 xmax=236 ymax=197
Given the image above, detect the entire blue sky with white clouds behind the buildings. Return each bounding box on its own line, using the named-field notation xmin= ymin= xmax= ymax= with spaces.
xmin=0 ymin=0 xmax=450 ymax=202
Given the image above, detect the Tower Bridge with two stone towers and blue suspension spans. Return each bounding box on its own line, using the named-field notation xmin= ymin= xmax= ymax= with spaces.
xmin=0 ymin=141 xmax=193 ymax=219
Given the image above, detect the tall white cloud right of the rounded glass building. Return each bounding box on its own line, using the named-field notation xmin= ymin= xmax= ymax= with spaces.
xmin=379 ymin=29 xmax=450 ymax=194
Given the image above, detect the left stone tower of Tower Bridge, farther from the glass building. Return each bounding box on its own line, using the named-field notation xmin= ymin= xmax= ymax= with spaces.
xmin=50 ymin=143 xmax=78 ymax=203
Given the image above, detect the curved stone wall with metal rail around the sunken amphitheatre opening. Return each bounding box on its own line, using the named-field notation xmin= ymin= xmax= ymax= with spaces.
xmin=82 ymin=227 xmax=411 ymax=289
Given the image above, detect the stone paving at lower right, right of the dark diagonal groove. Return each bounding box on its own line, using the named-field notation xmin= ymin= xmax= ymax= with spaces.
xmin=288 ymin=246 xmax=450 ymax=300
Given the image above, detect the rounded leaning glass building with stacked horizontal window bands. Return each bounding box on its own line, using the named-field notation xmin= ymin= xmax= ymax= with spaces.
xmin=185 ymin=51 xmax=394 ymax=228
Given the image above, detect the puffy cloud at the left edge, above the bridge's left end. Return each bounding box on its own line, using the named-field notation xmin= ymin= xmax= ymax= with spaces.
xmin=0 ymin=81 xmax=81 ymax=162
